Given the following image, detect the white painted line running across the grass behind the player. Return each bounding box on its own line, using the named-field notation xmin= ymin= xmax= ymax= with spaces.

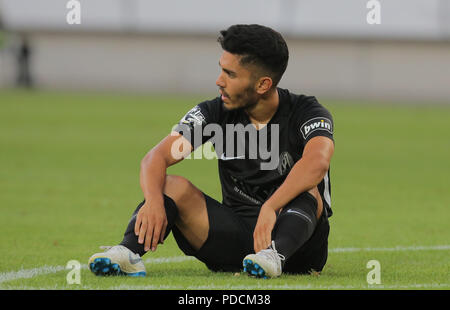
xmin=0 ymin=245 xmax=450 ymax=283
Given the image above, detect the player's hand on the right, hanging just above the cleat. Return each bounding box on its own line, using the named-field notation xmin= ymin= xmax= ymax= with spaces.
xmin=253 ymin=205 xmax=277 ymax=253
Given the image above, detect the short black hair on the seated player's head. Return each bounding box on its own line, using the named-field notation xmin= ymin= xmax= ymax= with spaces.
xmin=217 ymin=24 xmax=289 ymax=86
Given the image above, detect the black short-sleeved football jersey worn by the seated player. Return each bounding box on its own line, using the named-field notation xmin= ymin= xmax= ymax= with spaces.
xmin=175 ymin=88 xmax=334 ymax=216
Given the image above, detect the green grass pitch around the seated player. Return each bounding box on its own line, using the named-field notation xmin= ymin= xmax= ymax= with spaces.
xmin=0 ymin=91 xmax=450 ymax=290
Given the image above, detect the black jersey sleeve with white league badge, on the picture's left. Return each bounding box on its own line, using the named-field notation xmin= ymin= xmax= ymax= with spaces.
xmin=173 ymin=100 xmax=218 ymax=149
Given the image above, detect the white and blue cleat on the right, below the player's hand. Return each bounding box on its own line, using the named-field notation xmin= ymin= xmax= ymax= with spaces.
xmin=242 ymin=241 xmax=284 ymax=279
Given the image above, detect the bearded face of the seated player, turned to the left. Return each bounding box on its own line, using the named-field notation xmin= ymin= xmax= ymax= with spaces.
xmin=216 ymin=51 xmax=260 ymax=110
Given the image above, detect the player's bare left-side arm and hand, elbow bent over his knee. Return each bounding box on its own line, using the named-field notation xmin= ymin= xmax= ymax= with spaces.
xmin=134 ymin=133 xmax=192 ymax=251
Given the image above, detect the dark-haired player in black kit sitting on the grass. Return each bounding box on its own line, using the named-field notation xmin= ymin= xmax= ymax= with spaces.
xmin=89 ymin=25 xmax=334 ymax=278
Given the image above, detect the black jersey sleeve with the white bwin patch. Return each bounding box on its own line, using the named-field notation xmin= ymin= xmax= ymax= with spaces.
xmin=297 ymin=97 xmax=334 ymax=145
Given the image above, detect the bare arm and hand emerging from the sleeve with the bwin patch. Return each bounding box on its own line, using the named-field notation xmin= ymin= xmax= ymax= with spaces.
xmin=253 ymin=136 xmax=334 ymax=253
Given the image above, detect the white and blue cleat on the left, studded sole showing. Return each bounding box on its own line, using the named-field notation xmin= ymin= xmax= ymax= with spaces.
xmin=88 ymin=245 xmax=146 ymax=277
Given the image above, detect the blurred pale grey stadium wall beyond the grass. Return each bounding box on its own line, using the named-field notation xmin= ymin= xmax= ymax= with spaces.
xmin=0 ymin=0 xmax=450 ymax=103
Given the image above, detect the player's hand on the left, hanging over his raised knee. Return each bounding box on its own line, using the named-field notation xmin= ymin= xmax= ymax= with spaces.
xmin=134 ymin=200 xmax=167 ymax=251
